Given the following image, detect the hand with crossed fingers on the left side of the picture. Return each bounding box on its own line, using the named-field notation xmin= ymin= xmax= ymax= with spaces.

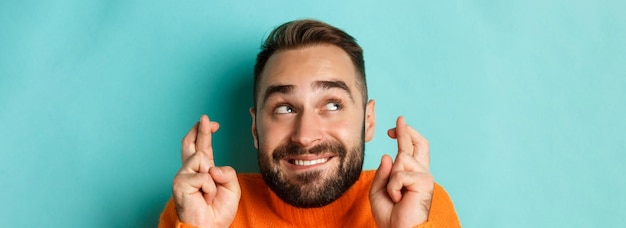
xmin=173 ymin=115 xmax=241 ymax=227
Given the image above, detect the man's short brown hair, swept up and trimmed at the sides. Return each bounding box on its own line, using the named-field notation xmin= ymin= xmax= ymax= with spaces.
xmin=253 ymin=20 xmax=367 ymax=109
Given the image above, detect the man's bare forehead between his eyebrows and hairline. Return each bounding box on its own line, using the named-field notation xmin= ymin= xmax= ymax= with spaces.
xmin=259 ymin=45 xmax=359 ymax=96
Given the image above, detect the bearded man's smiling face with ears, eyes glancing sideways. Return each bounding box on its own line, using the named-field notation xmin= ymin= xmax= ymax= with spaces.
xmin=251 ymin=45 xmax=375 ymax=207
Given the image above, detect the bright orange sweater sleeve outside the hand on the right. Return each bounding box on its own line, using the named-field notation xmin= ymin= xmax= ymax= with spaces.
xmin=417 ymin=183 xmax=461 ymax=228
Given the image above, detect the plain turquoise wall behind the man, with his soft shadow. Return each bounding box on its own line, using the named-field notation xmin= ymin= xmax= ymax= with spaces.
xmin=0 ymin=0 xmax=626 ymax=227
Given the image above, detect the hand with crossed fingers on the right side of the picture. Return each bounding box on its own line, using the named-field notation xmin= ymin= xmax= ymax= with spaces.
xmin=369 ymin=116 xmax=434 ymax=227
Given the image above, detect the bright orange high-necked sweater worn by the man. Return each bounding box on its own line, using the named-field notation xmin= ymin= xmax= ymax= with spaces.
xmin=159 ymin=171 xmax=461 ymax=228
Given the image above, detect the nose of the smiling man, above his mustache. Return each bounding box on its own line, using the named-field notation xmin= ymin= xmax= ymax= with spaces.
xmin=291 ymin=111 xmax=323 ymax=148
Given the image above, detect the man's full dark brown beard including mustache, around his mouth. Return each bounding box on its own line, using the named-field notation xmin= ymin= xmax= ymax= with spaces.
xmin=257 ymin=137 xmax=365 ymax=208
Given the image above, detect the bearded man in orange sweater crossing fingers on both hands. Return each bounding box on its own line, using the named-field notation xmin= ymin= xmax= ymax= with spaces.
xmin=160 ymin=20 xmax=460 ymax=227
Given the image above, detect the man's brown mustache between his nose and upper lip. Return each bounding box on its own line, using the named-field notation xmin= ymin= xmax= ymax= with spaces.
xmin=272 ymin=141 xmax=348 ymax=161
